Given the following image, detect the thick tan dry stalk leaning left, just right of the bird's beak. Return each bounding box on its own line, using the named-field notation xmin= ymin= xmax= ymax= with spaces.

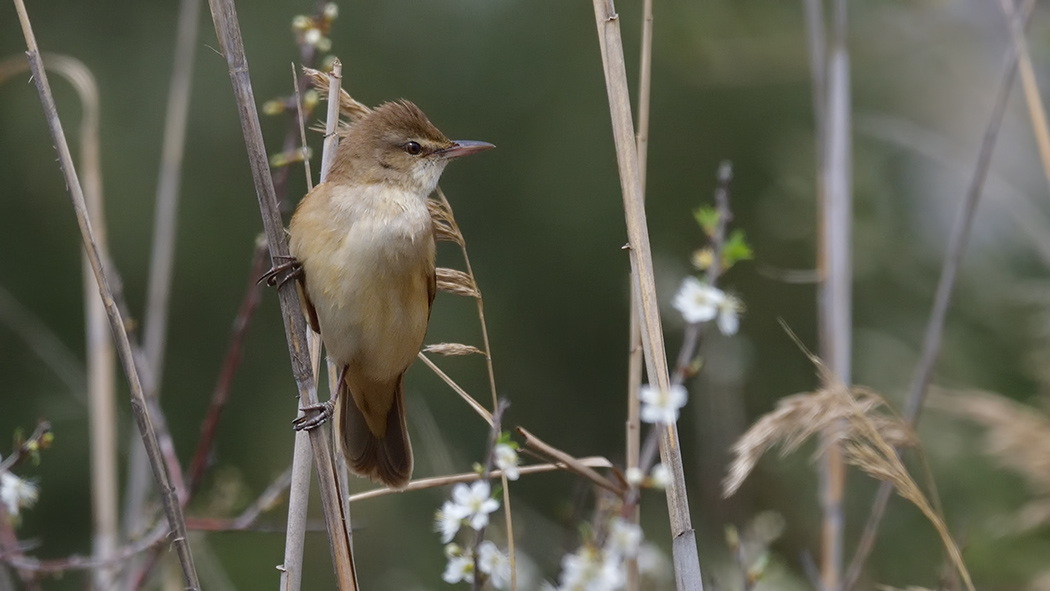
xmin=593 ymin=0 xmax=704 ymax=591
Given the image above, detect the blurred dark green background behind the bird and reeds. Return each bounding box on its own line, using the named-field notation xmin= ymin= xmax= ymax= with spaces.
xmin=0 ymin=0 xmax=1050 ymax=589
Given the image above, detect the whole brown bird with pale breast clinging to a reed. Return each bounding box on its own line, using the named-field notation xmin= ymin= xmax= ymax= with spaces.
xmin=289 ymin=101 xmax=495 ymax=488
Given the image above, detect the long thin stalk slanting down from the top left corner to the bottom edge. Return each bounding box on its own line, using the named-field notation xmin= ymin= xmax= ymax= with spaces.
xmin=15 ymin=0 xmax=201 ymax=590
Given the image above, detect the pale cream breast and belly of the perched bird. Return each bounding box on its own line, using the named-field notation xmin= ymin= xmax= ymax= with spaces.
xmin=290 ymin=185 xmax=435 ymax=379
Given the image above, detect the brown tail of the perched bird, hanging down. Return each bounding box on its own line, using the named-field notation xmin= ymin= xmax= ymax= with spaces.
xmin=336 ymin=372 xmax=413 ymax=488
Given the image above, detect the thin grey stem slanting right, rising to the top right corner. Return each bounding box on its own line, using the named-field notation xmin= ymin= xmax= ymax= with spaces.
xmin=842 ymin=0 xmax=1035 ymax=591
